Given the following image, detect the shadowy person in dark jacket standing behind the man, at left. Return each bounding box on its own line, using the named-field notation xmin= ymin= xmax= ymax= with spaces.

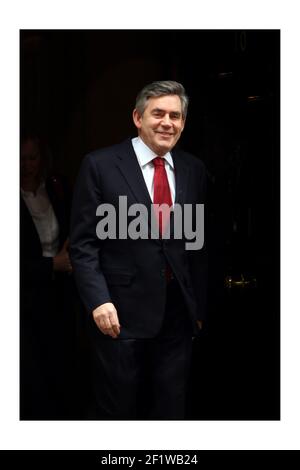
xmin=20 ymin=135 xmax=76 ymax=419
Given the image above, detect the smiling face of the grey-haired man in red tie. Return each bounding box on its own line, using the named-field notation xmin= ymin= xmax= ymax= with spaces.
xmin=133 ymin=95 xmax=184 ymax=156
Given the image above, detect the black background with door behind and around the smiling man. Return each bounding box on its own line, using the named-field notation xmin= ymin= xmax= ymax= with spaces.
xmin=20 ymin=30 xmax=280 ymax=420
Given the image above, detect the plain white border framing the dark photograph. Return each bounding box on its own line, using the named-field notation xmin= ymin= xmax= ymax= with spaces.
xmin=0 ymin=0 xmax=300 ymax=456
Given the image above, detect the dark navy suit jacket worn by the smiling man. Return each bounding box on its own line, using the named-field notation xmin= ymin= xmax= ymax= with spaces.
xmin=70 ymin=139 xmax=206 ymax=338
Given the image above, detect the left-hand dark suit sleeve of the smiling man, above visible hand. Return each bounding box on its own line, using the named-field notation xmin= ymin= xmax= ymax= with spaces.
xmin=70 ymin=155 xmax=111 ymax=313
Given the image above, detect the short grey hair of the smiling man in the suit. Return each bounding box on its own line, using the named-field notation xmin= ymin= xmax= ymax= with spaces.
xmin=135 ymin=80 xmax=189 ymax=119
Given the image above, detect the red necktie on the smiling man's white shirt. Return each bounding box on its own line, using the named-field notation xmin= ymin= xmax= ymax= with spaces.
xmin=152 ymin=157 xmax=172 ymax=236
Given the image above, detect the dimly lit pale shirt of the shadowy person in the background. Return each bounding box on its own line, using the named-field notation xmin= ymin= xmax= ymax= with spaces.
xmin=21 ymin=182 xmax=59 ymax=258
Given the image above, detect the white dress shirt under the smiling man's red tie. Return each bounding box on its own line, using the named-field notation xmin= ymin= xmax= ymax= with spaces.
xmin=132 ymin=137 xmax=175 ymax=204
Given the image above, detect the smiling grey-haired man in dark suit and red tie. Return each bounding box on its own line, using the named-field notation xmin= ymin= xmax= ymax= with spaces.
xmin=70 ymin=81 xmax=206 ymax=419
